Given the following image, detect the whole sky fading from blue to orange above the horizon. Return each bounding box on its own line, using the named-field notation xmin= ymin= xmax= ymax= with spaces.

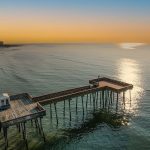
xmin=0 ymin=0 xmax=150 ymax=43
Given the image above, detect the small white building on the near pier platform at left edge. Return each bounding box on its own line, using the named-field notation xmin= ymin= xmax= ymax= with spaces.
xmin=0 ymin=93 xmax=10 ymax=109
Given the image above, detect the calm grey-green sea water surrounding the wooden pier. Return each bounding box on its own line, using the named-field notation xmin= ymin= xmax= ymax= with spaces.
xmin=0 ymin=44 xmax=150 ymax=150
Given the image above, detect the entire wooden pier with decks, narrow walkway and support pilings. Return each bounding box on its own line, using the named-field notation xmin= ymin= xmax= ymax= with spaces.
xmin=0 ymin=77 xmax=133 ymax=149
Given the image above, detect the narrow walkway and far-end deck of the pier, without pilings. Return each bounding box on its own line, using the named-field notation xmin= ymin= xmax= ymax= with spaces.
xmin=32 ymin=77 xmax=133 ymax=105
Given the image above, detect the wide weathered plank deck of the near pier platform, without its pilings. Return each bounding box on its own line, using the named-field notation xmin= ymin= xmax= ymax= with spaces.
xmin=0 ymin=94 xmax=45 ymax=126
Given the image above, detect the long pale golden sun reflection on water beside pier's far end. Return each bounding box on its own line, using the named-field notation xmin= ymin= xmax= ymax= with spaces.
xmin=117 ymin=58 xmax=143 ymax=111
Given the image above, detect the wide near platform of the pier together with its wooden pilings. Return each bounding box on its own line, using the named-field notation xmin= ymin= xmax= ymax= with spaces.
xmin=0 ymin=93 xmax=46 ymax=149
